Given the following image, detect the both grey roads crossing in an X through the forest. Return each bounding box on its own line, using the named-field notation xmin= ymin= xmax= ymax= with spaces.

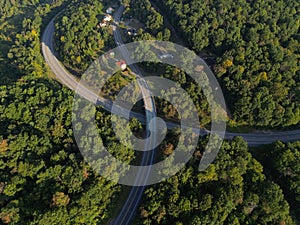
xmin=42 ymin=3 xmax=300 ymax=225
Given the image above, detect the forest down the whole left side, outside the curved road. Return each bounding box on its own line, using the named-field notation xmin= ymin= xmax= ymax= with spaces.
xmin=0 ymin=1 xmax=126 ymax=225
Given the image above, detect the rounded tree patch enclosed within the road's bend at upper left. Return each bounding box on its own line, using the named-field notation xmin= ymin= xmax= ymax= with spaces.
xmin=55 ymin=0 xmax=115 ymax=72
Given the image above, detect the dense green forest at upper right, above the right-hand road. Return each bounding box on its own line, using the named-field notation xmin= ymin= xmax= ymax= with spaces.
xmin=154 ymin=0 xmax=300 ymax=127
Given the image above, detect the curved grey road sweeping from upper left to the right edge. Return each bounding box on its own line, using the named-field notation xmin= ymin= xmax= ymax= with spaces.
xmin=42 ymin=14 xmax=300 ymax=146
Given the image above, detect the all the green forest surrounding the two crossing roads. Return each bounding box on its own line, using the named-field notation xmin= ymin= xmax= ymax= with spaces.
xmin=0 ymin=0 xmax=300 ymax=225
